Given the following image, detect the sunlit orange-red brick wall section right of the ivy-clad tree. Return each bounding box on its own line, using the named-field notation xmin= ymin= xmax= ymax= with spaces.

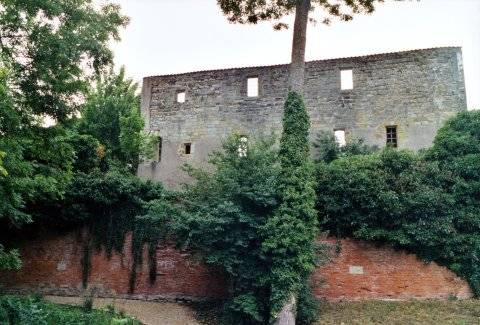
xmin=313 ymin=239 xmax=471 ymax=300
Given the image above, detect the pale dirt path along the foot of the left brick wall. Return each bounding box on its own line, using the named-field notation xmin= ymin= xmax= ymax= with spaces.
xmin=45 ymin=296 xmax=201 ymax=325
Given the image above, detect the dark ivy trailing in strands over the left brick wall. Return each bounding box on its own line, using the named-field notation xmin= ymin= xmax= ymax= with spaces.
xmin=54 ymin=169 xmax=171 ymax=292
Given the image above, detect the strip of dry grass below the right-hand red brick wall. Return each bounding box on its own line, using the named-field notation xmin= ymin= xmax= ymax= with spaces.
xmin=316 ymin=300 xmax=480 ymax=325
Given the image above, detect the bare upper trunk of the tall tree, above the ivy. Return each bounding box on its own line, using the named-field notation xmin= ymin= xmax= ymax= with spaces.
xmin=290 ymin=0 xmax=311 ymax=94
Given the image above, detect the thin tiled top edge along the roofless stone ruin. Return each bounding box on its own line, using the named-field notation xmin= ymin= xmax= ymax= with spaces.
xmin=143 ymin=46 xmax=462 ymax=79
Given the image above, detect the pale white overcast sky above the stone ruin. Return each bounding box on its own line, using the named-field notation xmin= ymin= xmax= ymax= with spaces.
xmin=109 ymin=0 xmax=480 ymax=108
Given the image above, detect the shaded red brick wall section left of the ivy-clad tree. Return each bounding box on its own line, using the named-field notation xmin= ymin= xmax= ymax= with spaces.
xmin=0 ymin=234 xmax=226 ymax=300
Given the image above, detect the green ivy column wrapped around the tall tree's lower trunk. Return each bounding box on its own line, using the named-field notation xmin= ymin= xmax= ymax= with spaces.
xmin=263 ymin=92 xmax=317 ymax=319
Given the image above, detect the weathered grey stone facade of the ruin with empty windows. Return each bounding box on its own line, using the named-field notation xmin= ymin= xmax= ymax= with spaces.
xmin=139 ymin=47 xmax=466 ymax=186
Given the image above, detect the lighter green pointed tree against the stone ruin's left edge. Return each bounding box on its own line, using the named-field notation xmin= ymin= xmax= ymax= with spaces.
xmin=78 ymin=68 xmax=148 ymax=172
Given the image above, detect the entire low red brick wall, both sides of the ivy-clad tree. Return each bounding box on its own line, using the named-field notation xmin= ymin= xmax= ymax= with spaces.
xmin=0 ymin=234 xmax=471 ymax=300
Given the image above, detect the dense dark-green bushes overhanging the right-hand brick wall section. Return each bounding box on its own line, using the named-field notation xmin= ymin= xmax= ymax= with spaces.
xmin=317 ymin=111 xmax=480 ymax=295
